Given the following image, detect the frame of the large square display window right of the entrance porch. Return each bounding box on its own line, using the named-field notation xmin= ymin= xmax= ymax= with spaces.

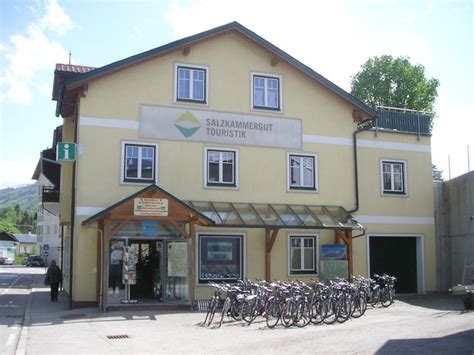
xmin=194 ymin=232 xmax=247 ymax=286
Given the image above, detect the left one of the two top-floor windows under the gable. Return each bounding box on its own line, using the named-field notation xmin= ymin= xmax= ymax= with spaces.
xmin=175 ymin=63 xmax=209 ymax=104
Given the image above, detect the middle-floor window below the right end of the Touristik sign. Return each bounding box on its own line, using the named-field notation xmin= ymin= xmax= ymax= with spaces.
xmin=287 ymin=153 xmax=318 ymax=191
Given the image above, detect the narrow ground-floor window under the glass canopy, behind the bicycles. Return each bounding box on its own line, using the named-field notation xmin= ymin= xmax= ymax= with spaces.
xmin=288 ymin=234 xmax=319 ymax=276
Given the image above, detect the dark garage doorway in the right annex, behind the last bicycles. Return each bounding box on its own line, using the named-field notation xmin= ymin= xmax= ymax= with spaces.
xmin=369 ymin=236 xmax=418 ymax=293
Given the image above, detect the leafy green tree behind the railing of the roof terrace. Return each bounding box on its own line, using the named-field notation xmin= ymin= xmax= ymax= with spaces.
xmin=351 ymin=55 xmax=439 ymax=112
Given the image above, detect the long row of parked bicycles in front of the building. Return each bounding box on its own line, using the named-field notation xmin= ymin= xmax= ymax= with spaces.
xmin=201 ymin=274 xmax=396 ymax=328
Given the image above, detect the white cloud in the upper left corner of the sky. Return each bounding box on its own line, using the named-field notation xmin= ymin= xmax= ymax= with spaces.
xmin=0 ymin=0 xmax=73 ymax=104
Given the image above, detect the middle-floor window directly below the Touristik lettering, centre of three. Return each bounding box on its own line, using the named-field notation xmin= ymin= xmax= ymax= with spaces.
xmin=204 ymin=148 xmax=239 ymax=188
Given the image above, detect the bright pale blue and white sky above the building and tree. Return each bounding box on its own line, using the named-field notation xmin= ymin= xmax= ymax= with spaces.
xmin=0 ymin=0 xmax=474 ymax=188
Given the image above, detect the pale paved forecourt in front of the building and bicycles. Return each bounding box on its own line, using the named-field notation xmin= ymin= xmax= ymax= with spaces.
xmin=0 ymin=268 xmax=474 ymax=354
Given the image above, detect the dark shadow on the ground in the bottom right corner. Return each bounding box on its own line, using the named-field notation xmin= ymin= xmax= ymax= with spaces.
xmin=376 ymin=330 xmax=474 ymax=354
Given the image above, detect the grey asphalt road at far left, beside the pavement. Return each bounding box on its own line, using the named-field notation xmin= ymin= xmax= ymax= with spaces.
xmin=0 ymin=265 xmax=45 ymax=354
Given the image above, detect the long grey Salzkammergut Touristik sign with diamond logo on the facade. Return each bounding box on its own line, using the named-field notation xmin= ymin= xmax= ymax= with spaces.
xmin=139 ymin=105 xmax=302 ymax=149
